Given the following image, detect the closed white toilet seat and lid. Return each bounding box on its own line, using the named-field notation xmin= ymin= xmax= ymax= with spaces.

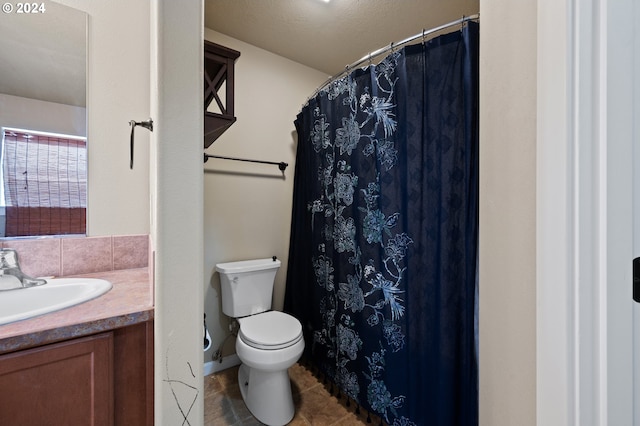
xmin=238 ymin=311 xmax=302 ymax=350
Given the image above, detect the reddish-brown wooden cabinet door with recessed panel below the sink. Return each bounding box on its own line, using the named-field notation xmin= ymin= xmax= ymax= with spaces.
xmin=0 ymin=332 xmax=113 ymax=426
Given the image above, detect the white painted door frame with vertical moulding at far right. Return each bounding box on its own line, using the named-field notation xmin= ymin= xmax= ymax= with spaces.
xmin=536 ymin=0 xmax=634 ymax=426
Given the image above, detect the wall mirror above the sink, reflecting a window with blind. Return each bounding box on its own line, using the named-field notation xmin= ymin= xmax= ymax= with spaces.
xmin=0 ymin=1 xmax=87 ymax=237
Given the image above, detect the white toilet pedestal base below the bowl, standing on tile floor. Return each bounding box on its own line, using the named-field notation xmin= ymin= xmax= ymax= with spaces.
xmin=238 ymin=364 xmax=295 ymax=426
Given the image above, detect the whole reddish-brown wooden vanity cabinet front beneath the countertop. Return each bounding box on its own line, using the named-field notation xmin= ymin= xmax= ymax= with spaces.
xmin=0 ymin=321 xmax=153 ymax=426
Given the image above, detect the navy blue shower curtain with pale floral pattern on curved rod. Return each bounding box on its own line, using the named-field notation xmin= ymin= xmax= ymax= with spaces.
xmin=285 ymin=22 xmax=478 ymax=426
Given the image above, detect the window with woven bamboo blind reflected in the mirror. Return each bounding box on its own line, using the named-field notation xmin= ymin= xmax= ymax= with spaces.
xmin=2 ymin=130 xmax=87 ymax=236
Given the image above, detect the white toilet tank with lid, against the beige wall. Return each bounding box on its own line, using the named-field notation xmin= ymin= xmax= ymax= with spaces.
xmin=216 ymin=258 xmax=280 ymax=318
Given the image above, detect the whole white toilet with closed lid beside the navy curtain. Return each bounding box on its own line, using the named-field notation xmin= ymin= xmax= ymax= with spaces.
xmin=216 ymin=256 xmax=304 ymax=426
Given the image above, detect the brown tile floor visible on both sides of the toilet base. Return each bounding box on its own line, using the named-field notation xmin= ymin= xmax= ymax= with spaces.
xmin=204 ymin=363 xmax=381 ymax=426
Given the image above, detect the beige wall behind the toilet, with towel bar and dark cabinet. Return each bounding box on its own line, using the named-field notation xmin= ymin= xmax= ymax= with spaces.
xmin=204 ymin=29 xmax=327 ymax=362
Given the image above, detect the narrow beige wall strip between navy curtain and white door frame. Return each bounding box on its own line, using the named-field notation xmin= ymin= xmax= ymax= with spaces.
xmin=479 ymin=0 xmax=537 ymax=426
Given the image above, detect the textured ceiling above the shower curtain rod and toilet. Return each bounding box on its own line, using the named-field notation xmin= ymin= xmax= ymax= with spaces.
xmin=204 ymin=0 xmax=479 ymax=75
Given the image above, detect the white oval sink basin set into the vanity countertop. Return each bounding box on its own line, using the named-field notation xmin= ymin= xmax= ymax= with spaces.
xmin=0 ymin=278 xmax=112 ymax=325
